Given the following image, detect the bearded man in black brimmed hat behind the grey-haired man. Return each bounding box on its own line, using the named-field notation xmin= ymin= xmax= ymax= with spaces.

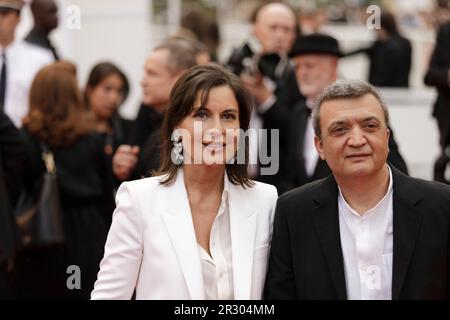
xmin=286 ymin=34 xmax=407 ymax=188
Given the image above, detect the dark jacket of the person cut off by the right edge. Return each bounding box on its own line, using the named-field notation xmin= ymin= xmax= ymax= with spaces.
xmin=425 ymin=22 xmax=450 ymax=144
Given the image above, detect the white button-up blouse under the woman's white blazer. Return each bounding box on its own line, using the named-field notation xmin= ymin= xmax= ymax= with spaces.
xmin=197 ymin=177 xmax=234 ymax=300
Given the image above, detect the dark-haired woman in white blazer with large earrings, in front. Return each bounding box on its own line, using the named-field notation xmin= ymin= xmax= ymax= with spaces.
xmin=91 ymin=64 xmax=277 ymax=300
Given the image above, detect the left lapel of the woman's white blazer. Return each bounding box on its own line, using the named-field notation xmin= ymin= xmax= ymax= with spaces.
xmin=162 ymin=169 xmax=205 ymax=300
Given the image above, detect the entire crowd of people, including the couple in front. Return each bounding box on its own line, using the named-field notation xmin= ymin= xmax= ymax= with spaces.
xmin=0 ymin=0 xmax=450 ymax=299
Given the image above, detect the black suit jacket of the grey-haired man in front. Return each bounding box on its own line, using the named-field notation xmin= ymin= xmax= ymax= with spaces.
xmin=265 ymin=168 xmax=450 ymax=299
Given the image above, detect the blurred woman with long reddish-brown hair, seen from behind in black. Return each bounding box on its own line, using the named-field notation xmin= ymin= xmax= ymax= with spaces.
xmin=14 ymin=62 xmax=113 ymax=299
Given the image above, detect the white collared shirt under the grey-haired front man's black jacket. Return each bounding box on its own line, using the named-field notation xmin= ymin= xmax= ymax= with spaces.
xmin=338 ymin=167 xmax=393 ymax=300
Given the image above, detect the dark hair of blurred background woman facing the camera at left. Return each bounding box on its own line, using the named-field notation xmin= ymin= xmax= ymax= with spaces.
xmin=84 ymin=62 xmax=130 ymax=106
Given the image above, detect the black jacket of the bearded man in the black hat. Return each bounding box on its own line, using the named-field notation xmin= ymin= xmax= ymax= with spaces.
xmin=285 ymin=102 xmax=408 ymax=189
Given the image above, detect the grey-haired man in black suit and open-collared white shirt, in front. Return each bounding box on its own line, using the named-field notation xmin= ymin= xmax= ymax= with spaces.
xmin=265 ymin=80 xmax=450 ymax=300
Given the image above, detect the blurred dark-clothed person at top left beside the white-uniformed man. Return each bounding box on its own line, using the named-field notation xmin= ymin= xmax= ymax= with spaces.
xmin=24 ymin=0 xmax=59 ymax=60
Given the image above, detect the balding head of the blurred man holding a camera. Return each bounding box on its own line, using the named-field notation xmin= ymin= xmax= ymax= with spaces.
xmin=253 ymin=2 xmax=297 ymax=55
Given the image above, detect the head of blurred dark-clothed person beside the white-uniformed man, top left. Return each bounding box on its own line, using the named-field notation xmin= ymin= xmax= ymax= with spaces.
xmin=30 ymin=0 xmax=58 ymax=32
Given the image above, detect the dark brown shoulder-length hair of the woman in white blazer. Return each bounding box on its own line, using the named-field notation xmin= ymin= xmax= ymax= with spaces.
xmin=154 ymin=64 xmax=254 ymax=188
